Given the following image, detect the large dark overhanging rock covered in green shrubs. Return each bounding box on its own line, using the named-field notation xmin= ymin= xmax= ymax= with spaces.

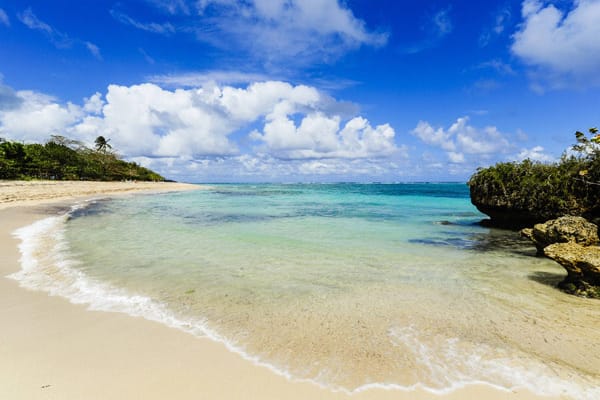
xmin=468 ymin=128 xmax=600 ymax=228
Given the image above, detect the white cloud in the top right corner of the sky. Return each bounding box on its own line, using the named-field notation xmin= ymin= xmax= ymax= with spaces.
xmin=511 ymin=0 xmax=600 ymax=87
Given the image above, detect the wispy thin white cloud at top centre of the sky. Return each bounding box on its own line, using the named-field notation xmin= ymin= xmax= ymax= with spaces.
xmin=162 ymin=0 xmax=387 ymax=66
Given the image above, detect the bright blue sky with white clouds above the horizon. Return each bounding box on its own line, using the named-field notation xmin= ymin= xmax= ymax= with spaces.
xmin=0 ymin=0 xmax=600 ymax=182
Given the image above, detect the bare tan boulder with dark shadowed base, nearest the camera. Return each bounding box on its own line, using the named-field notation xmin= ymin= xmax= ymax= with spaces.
xmin=544 ymin=242 xmax=600 ymax=298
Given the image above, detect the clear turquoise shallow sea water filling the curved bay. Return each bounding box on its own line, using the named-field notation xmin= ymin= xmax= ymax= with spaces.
xmin=11 ymin=183 xmax=600 ymax=400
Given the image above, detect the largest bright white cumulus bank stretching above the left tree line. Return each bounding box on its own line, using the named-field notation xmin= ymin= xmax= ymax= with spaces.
xmin=0 ymin=81 xmax=406 ymax=180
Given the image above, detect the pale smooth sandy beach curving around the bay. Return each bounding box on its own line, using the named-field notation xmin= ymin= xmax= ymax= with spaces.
xmin=0 ymin=181 xmax=552 ymax=400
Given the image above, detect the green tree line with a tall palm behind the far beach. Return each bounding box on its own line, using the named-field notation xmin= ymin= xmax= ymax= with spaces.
xmin=0 ymin=135 xmax=165 ymax=181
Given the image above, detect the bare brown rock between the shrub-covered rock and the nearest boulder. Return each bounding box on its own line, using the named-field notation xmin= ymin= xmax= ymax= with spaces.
xmin=521 ymin=215 xmax=599 ymax=255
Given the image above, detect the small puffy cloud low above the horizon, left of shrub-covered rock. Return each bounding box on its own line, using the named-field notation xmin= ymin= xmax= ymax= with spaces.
xmin=412 ymin=117 xmax=511 ymax=164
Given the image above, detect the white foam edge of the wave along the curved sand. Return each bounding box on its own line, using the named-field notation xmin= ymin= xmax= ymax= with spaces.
xmin=7 ymin=205 xmax=598 ymax=399
